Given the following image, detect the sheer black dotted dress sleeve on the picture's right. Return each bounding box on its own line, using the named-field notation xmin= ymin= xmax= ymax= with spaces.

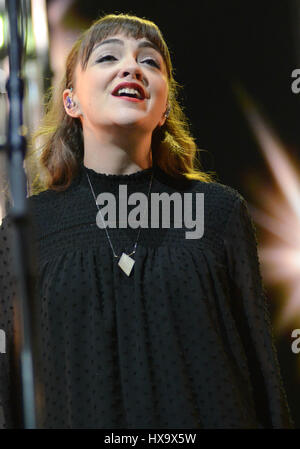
xmin=224 ymin=194 xmax=294 ymax=428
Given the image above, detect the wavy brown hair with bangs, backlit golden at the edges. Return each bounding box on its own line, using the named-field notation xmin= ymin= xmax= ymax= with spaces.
xmin=26 ymin=14 xmax=215 ymax=194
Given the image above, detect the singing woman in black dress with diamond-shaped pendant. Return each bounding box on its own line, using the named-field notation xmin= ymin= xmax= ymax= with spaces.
xmin=0 ymin=14 xmax=293 ymax=429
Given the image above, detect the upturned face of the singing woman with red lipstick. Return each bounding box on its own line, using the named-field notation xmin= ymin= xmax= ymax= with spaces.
xmin=64 ymin=34 xmax=168 ymax=133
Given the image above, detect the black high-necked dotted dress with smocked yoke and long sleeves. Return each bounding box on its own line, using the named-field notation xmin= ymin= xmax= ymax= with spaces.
xmin=0 ymin=161 xmax=294 ymax=429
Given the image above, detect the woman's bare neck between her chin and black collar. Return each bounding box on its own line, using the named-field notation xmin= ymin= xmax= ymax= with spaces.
xmin=83 ymin=130 xmax=152 ymax=174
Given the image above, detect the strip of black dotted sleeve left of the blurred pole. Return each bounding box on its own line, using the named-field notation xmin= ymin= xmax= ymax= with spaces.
xmin=0 ymin=216 xmax=14 ymax=429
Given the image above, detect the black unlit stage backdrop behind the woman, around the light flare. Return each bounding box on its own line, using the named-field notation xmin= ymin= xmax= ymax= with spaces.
xmin=48 ymin=0 xmax=300 ymax=427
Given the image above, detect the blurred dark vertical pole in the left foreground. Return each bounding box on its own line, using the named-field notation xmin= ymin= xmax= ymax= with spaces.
xmin=6 ymin=0 xmax=37 ymax=429
